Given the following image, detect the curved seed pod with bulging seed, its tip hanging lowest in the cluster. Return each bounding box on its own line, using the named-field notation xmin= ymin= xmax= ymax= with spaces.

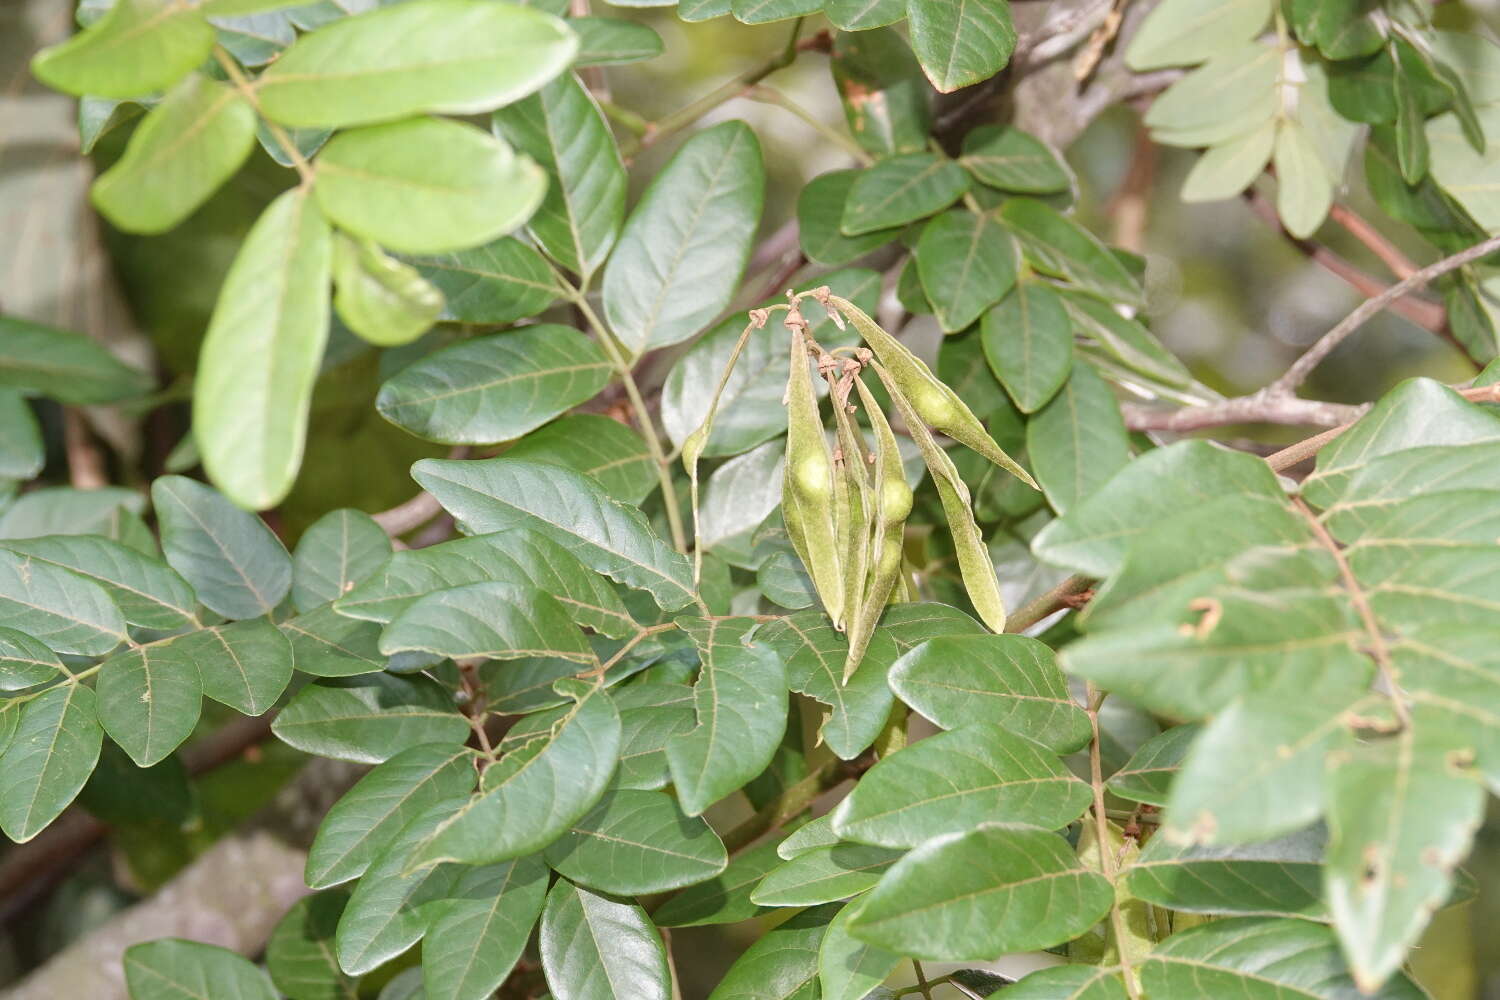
xmin=843 ymin=378 xmax=912 ymax=684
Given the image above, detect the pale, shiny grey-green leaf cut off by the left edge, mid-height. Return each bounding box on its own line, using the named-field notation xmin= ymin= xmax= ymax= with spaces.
xmin=0 ymin=549 xmax=126 ymax=657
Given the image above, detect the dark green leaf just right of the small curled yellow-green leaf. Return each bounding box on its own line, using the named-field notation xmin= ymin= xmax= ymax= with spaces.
xmin=411 ymin=235 xmax=560 ymax=324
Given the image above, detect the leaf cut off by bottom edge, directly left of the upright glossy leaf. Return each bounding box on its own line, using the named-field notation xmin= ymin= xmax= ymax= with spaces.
xmin=422 ymin=858 xmax=548 ymax=1000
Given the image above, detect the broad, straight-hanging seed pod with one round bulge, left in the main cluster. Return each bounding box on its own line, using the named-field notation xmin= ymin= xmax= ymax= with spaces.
xmin=782 ymin=326 xmax=843 ymax=622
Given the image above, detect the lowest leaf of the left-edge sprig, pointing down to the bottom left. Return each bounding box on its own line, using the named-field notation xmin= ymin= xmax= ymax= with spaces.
xmin=0 ymin=682 xmax=104 ymax=844
